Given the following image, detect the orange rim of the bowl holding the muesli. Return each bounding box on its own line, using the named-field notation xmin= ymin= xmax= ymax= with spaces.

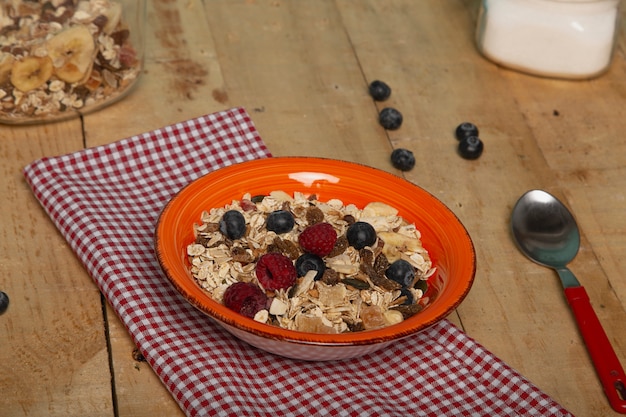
xmin=153 ymin=156 xmax=476 ymax=346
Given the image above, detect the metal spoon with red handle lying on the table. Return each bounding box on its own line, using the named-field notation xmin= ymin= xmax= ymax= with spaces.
xmin=511 ymin=190 xmax=626 ymax=414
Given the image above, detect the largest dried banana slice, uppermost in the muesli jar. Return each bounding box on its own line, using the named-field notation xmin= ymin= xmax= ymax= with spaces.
xmin=46 ymin=26 xmax=96 ymax=83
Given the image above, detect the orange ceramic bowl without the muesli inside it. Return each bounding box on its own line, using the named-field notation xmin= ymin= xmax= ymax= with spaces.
xmin=155 ymin=157 xmax=476 ymax=360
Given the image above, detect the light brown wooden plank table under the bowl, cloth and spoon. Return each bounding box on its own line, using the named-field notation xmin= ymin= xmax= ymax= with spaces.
xmin=0 ymin=0 xmax=626 ymax=417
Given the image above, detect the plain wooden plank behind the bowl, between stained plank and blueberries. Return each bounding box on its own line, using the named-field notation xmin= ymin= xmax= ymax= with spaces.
xmin=205 ymin=0 xmax=393 ymax=170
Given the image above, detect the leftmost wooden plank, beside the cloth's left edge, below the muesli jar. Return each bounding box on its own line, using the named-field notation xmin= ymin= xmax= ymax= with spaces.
xmin=0 ymin=120 xmax=113 ymax=417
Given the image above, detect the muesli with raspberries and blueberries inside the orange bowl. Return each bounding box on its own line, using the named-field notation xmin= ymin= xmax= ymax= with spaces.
xmin=187 ymin=191 xmax=435 ymax=333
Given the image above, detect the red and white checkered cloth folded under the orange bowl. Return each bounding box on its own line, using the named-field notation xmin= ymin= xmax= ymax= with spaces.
xmin=24 ymin=108 xmax=570 ymax=417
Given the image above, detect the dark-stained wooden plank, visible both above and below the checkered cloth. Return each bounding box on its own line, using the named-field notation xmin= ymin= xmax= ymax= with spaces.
xmin=85 ymin=0 xmax=222 ymax=417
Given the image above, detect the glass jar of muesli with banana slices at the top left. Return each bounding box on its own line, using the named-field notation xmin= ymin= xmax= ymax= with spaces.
xmin=0 ymin=0 xmax=145 ymax=124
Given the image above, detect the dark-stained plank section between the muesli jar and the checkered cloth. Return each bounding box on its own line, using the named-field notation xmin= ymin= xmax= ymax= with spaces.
xmin=85 ymin=0 xmax=229 ymax=146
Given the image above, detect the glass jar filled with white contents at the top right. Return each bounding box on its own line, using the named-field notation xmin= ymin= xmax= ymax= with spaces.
xmin=476 ymin=0 xmax=619 ymax=79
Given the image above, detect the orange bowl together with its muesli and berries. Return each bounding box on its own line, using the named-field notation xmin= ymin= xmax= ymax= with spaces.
xmin=155 ymin=157 xmax=476 ymax=360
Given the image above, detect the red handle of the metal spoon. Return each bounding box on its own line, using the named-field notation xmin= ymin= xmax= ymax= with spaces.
xmin=565 ymin=286 xmax=626 ymax=414
